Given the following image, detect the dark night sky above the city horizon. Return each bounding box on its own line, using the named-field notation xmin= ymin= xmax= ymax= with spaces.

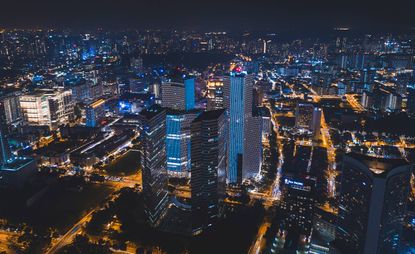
xmin=0 ymin=0 xmax=415 ymax=31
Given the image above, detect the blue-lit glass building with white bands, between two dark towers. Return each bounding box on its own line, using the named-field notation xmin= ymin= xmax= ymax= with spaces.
xmin=166 ymin=109 xmax=199 ymax=177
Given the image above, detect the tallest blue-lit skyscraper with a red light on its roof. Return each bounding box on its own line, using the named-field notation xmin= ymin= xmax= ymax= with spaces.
xmin=224 ymin=70 xmax=261 ymax=184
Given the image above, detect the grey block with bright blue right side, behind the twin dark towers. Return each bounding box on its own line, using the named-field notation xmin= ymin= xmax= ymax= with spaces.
xmin=161 ymin=76 xmax=195 ymax=110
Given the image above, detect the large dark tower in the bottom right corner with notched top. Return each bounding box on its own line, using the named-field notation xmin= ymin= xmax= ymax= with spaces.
xmin=336 ymin=153 xmax=412 ymax=253
